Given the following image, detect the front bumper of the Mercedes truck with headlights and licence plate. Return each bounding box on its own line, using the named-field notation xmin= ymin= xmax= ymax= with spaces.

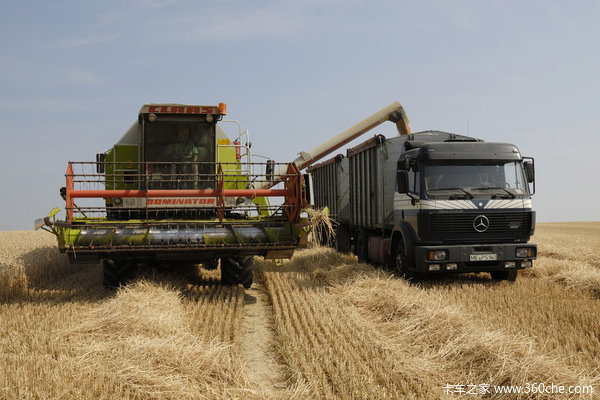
xmin=414 ymin=243 xmax=537 ymax=274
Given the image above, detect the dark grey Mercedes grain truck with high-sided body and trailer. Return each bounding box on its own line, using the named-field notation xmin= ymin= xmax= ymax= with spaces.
xmin=308 ymin=129 xmax=537 ymax=281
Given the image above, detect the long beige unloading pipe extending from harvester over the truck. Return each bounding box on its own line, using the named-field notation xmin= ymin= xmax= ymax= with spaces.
xmin=259 ymin=101 xmax=410 ymax=186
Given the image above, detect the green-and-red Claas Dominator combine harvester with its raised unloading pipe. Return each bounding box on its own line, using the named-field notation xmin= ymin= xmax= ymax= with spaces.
xmin=35 ymin=103 xmax=408 ymax=288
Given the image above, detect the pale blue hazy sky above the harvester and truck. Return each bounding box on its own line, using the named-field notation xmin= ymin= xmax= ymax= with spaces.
xmin=0 ymin=0 xmax=600 ymax=230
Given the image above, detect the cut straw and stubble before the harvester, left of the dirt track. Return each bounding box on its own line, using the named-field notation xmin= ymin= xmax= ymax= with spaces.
xmin=0 ymin=279 xmax=271 ymax=399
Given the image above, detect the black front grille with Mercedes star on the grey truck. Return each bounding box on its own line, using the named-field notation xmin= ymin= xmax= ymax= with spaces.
xmin=419 ymin=211 xmax=532 ymax=242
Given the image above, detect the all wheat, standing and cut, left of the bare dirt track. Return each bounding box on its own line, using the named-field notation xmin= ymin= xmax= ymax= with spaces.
xmin=0 ymin=232 xmax=274 ymax=399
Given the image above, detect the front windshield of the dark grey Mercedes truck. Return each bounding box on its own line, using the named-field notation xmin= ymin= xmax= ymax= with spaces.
xmin=424 ymin=161 xmax=527 ymax=198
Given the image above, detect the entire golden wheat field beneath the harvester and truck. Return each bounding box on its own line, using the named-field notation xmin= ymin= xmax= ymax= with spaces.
xmin=0 ymin=223 xmax=600 ymax=399
